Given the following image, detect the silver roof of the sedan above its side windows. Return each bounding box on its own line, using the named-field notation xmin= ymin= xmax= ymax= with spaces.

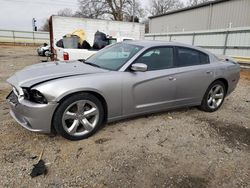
xmin=124 ymin=40 xmax=211 ymax=54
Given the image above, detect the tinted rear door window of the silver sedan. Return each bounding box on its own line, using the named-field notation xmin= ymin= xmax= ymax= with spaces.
xmin=177 ymin=47 xmax=209 ymax=67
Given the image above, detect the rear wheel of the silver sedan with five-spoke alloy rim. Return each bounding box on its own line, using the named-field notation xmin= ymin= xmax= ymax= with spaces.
xmin=199 ymin=80 xmax=226 ymax=112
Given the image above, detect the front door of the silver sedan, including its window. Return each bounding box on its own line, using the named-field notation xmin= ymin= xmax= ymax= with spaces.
xmin=123 ymin=47 xmax=176 ymax=115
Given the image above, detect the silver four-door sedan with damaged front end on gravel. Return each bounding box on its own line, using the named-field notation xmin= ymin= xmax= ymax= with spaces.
xmin=7 ymin=41 xmax=240 ymax=140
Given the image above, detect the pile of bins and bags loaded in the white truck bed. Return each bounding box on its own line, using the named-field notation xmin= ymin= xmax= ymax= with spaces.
xmin=56 ymin=29 xmax=109 ymax=50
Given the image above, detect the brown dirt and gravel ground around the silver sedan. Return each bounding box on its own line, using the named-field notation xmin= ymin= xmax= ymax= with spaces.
xmin=0 ymin=46 xmax=250 ymax=188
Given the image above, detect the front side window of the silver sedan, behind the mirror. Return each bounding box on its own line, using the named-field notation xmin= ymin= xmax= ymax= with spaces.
xmin=135 ymin=47 xmax=174 ymax=71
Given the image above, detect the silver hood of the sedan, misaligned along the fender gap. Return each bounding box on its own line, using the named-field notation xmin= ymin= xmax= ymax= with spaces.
xmin=7 ymin=61 xmax=108 ymax=87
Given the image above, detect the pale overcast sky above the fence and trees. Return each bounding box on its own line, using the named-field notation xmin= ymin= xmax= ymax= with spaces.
xmin=0 ymin=0 xmax=188 ymax=31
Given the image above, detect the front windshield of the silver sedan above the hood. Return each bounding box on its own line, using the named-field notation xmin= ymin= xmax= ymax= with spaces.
xmin=85 ymin=43 xmax=143 ymax=70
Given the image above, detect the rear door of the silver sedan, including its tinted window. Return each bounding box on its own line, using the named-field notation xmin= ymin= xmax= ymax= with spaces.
xmin=175 ymin=47 xmax=214 ymax=106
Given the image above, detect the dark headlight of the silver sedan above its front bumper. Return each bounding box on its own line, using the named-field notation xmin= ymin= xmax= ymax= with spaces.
xmin=23 ymin=88 xmax=48 ymax=104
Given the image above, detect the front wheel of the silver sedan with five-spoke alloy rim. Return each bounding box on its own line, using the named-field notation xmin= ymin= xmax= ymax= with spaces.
xmin=52 ymin=93 xmax=104 ymax=140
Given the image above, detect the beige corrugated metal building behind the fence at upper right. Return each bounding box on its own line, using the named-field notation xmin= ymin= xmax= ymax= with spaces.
xmin=149 ymin=0 xmax=250 ymax=33
